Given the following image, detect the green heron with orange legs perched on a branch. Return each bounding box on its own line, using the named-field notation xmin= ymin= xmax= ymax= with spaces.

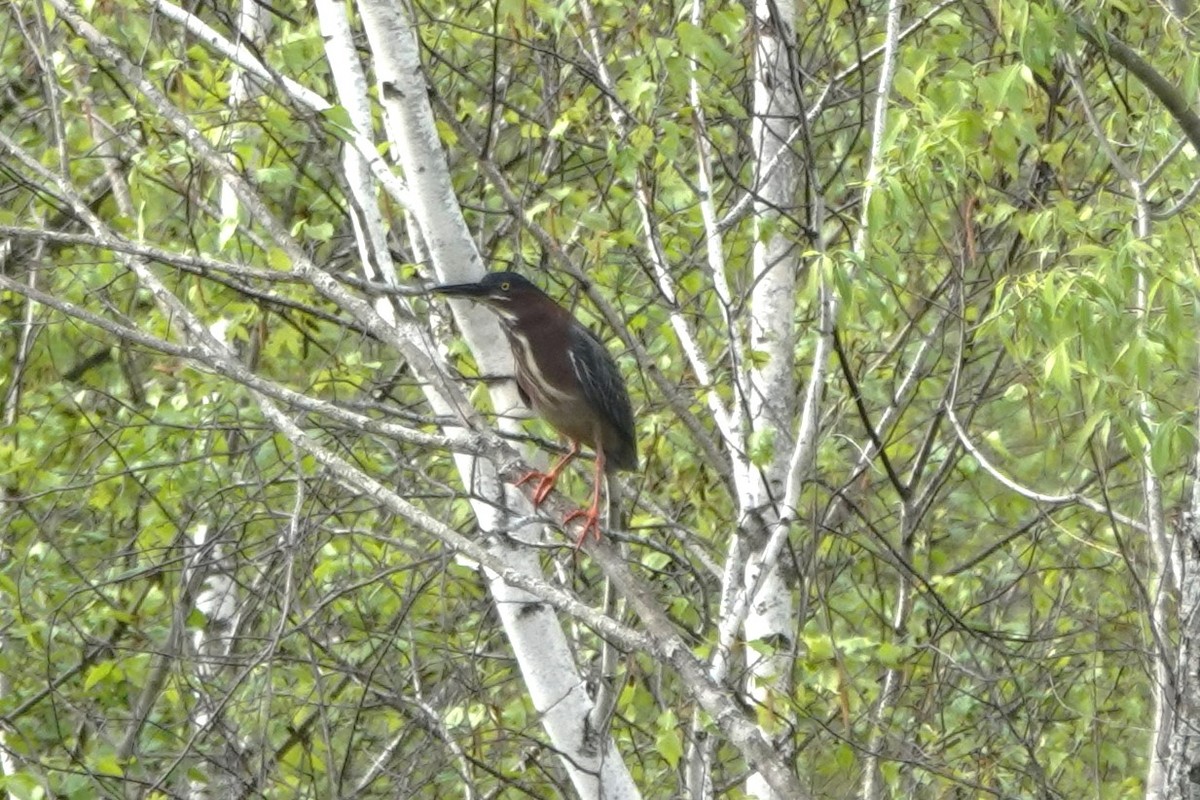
xmin=433 ymin=272 xmax=637 ymax=547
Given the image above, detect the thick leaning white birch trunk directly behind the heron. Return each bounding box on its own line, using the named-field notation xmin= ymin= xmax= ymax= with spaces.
xmin=359 ymin=0 xmax=640 ymax=800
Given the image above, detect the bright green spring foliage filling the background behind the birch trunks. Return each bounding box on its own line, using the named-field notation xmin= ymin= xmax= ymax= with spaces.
xmin=0 ymin=0 xmax=1198 ymax=798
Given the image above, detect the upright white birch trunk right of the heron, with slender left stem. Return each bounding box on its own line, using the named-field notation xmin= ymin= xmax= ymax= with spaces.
xmin=685 ymin=0 xmax=803 ymax=800
